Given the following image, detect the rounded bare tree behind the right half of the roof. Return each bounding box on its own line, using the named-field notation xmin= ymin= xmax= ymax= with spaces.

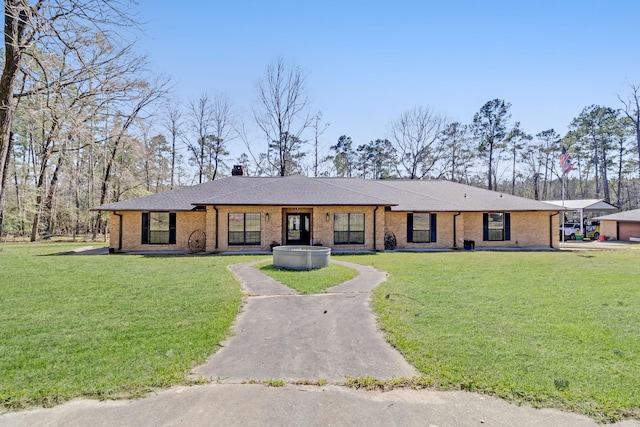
xmin=391 ymin=107 xmax=446 ymax=179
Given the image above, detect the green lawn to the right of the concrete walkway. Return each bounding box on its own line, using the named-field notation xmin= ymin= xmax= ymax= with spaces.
xmin=345 ymin=251 xmax=640 ymax=422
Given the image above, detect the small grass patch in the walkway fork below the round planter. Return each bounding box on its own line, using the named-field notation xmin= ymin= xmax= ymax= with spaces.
xmin=256 ymin=261 xmax=358 ymax=294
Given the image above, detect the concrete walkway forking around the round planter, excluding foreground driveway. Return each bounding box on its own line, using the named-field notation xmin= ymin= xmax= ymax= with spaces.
xmin=195 ymin=262 xmax=417 ymax=383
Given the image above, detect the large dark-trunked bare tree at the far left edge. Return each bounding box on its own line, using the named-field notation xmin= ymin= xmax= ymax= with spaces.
xmin=0 ymin=0 xmax=139 ymax=231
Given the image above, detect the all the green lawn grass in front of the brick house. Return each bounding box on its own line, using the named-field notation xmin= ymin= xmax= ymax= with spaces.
xmin=0 ymin=243 xmax=640 ymax=422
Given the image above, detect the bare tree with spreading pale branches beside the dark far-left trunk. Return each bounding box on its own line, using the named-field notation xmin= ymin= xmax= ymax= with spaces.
xmin=15 ymin=31 xmax=154 ymax=241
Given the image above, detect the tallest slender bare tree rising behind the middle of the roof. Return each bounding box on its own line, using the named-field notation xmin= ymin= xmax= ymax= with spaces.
xmin=253 ymin=58 xmax=313 ymax=176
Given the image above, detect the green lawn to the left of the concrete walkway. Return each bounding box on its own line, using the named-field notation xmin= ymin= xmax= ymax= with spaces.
xmin=0 ymin=243 xmax=255 ymax=412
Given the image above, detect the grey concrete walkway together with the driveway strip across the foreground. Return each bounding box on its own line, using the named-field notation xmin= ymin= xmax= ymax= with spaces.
xmin=0 ymin=261 xmax=640 ymax=427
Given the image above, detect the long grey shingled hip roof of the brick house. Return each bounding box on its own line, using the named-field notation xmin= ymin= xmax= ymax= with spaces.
xmin=93 ymin=175 xmax=562 ymax=212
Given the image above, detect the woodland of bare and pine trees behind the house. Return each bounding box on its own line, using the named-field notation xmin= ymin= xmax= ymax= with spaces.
xmin=0 ymin=0 xmax=640 ymax=241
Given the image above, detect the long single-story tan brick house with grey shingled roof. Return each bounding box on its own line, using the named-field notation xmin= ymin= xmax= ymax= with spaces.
xmin=93 ymin=175 xmax=562 ymax=252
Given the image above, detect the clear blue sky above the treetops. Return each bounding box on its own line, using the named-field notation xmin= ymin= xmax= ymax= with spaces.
xmin=138 ymin=0 xmax=640 ymax=160
